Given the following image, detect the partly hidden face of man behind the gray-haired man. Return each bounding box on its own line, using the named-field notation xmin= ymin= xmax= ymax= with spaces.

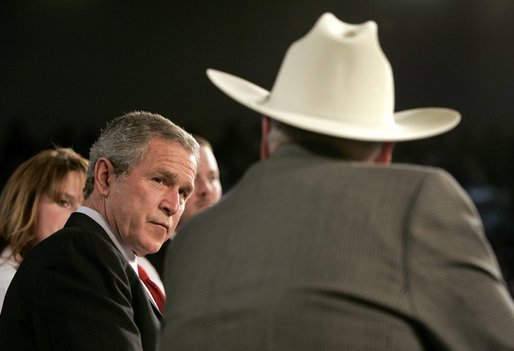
xmin=180 ymin=146 xmax=221 ymax=230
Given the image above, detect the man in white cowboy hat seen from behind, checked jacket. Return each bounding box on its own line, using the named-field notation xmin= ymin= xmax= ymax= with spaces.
xmin=161 ymin=13 xmax=514 ymax=351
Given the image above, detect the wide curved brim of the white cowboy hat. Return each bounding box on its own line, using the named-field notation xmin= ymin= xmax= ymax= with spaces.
xmin=207 ymin=69 xmax=461 ymax=141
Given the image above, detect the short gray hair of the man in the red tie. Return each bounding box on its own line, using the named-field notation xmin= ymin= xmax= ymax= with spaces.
xmin=84 ymin=111 xmax=199 ymax=199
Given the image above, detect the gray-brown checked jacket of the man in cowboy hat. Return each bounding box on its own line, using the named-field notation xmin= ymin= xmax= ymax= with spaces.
xmin=161 ymin=146 xmax=514 ymax=351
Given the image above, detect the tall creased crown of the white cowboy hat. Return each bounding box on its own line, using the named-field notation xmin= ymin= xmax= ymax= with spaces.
xmin=263 ymin=14 xmax=394 ymax=126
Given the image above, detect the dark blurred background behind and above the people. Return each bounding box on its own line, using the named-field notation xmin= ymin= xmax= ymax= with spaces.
xmin=0 ymin=0 xmax=514 ymax=292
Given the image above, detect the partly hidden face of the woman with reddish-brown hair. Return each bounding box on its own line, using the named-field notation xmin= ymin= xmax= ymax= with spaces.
xmin=36 ymin=171 xmax=86 ymax=243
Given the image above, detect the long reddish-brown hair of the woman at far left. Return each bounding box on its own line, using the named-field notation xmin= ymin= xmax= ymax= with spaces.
xmin=0 ymin=147 xmax=88 ymax=262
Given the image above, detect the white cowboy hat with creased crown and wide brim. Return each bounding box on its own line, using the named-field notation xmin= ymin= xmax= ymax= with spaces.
xmin=207 ymin=13 xmax=460 ymax=141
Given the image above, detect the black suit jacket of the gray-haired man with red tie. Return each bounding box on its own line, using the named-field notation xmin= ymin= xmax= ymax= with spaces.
xmin=0 ymin=213 xmax=160 ymax=351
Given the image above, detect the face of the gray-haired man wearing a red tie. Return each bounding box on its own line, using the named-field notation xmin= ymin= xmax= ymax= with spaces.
xmin=105 ymin=138 xmax=196 ymax=256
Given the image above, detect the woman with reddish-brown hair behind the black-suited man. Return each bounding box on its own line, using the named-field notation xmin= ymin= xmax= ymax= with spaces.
xmin=0 ymin=147 xmax=88 ymax=308
